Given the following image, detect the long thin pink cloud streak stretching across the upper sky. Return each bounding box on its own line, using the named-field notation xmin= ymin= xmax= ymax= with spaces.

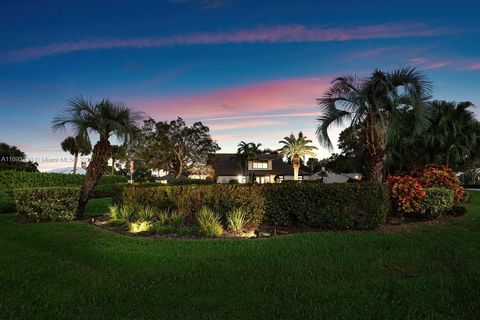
xmin=0 ymin=22 xmax=456 ymax=63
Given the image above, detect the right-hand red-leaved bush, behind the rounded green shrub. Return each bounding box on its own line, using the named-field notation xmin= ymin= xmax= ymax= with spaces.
xmin=419 ymin=165 xmax=465 ymax=202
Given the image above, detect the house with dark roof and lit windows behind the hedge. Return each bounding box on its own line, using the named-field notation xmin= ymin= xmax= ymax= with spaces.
xmin=210 ymin=153 xmax=309 ymax=183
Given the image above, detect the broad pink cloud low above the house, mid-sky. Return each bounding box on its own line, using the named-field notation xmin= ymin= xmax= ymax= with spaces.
xmin=130 ymin=77 xmax=331 ymax=120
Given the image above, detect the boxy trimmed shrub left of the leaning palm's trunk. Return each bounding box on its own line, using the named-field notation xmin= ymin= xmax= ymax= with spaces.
xmin=15 ymin=188 xmax=80 ymax=222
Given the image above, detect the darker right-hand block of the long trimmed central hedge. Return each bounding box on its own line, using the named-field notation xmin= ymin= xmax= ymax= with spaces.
xmin=264 ymin=183 xmax=390 ymax=229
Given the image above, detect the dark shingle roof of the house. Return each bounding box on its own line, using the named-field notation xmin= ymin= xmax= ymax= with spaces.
xmin=211 ymin=153 xmax=309 ymax=176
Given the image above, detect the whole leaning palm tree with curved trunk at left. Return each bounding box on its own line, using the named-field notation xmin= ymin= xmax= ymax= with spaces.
xmin=52 ymin=97 xmax=140 ymax=216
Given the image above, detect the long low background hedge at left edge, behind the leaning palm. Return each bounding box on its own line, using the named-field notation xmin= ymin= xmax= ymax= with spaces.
xmin=0 ymin=171 xmax=127 ymax=191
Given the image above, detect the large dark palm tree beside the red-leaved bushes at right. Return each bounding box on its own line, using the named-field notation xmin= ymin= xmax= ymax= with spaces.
xmin=317 ymin=67 xmax=432 ymax=182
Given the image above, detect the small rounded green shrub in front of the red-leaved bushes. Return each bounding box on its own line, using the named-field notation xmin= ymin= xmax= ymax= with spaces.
xmin=421 ymin=188 xmax=455 ymax=218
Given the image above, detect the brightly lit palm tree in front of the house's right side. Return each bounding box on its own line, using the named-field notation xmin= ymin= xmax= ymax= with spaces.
xmin=278 ymin=131 xmax=317 ymax=180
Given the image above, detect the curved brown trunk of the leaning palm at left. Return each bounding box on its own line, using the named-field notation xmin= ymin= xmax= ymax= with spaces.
xmin=77 ymin=139 xmax=111 ymax=217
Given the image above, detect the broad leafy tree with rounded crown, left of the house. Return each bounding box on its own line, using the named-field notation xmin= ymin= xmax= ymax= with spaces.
xmin=135 ymin=117 xmax=220 ymax=178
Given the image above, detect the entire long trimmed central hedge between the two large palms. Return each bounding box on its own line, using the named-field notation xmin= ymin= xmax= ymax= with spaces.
xmin=113 ymin=183 xmax=390 ymax=229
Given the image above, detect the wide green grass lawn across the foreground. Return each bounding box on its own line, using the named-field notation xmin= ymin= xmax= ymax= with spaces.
xmin=0 ymin=193 xmax=480 ymax=319
